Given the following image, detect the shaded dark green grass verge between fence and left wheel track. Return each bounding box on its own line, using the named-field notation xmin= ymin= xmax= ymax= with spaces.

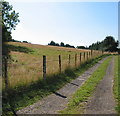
xmin=2 ymin=55 xmax=109 ymax=115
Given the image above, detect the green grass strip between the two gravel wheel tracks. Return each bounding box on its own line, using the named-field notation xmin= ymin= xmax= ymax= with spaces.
xmin=59 ymin=56 xmax=112 ymax=114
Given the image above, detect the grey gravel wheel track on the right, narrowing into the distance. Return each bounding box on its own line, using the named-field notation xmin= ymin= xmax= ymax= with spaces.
xmin=84 ymin=57 xmax=116 ymax=115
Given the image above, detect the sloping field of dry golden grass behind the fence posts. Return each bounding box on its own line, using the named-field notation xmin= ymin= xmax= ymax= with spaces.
xmin=3 ymin=42 xmax=102 ymax=88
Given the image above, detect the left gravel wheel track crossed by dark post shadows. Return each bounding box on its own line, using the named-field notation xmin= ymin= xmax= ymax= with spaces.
xmin=17 ymin=57 xmax=107 ymax=115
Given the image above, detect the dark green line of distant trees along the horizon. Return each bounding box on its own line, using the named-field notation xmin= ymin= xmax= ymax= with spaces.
xmin=48 ymin=36 xmax=119 ymax=52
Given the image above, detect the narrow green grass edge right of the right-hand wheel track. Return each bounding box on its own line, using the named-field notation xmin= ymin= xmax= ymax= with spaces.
xmin=113 ymin=55 xmax=120 ymax=116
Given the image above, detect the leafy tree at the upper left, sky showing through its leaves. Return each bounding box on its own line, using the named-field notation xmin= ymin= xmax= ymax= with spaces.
xmin=0 ymin=1 xmax=20 ymax=56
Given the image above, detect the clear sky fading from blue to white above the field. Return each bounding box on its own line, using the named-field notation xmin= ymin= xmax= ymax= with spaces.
xmin=7 ymin=1 xmax=118 ymax=46
